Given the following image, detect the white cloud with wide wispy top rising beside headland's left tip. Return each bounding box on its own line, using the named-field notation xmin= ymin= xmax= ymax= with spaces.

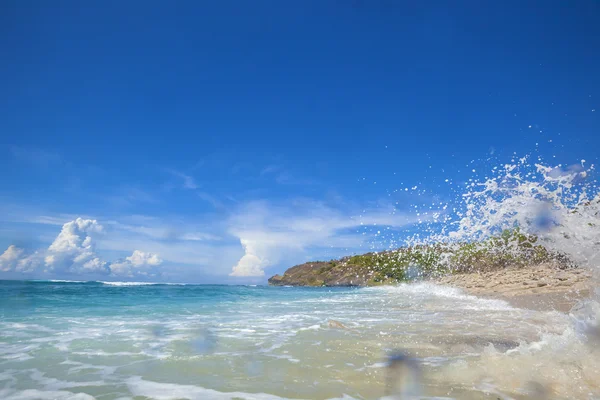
xmin=229 ymin=200 xmax=415 ymax=277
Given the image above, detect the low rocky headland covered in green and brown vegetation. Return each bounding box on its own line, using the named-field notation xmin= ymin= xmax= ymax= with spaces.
xmin=269 ymin=229 xmax=572 ymax=286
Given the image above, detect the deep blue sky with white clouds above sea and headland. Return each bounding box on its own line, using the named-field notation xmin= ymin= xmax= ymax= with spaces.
xmin=0 ymin=0 xmax=600 ymax=283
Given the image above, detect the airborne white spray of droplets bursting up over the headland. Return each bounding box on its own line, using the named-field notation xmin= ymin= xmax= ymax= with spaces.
xmin=407 ymin=156 xmax=600 ymax=264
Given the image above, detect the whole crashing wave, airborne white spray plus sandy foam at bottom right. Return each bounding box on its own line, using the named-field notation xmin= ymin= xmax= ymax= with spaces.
xmin=390 ymin=156 xmax=600 ymax=399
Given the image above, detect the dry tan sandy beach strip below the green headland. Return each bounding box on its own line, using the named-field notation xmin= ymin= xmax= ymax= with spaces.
xmin=432 ymin=264 xmax=592 ymax=313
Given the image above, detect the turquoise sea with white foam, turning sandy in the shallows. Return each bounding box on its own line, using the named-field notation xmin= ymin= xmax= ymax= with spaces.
xmin=0 ymin=281 xmax=600 ymax=400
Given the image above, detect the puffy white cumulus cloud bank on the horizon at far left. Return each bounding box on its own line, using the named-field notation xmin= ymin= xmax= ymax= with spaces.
xmin=0 ymin=218 xmax=162 ymax=276
